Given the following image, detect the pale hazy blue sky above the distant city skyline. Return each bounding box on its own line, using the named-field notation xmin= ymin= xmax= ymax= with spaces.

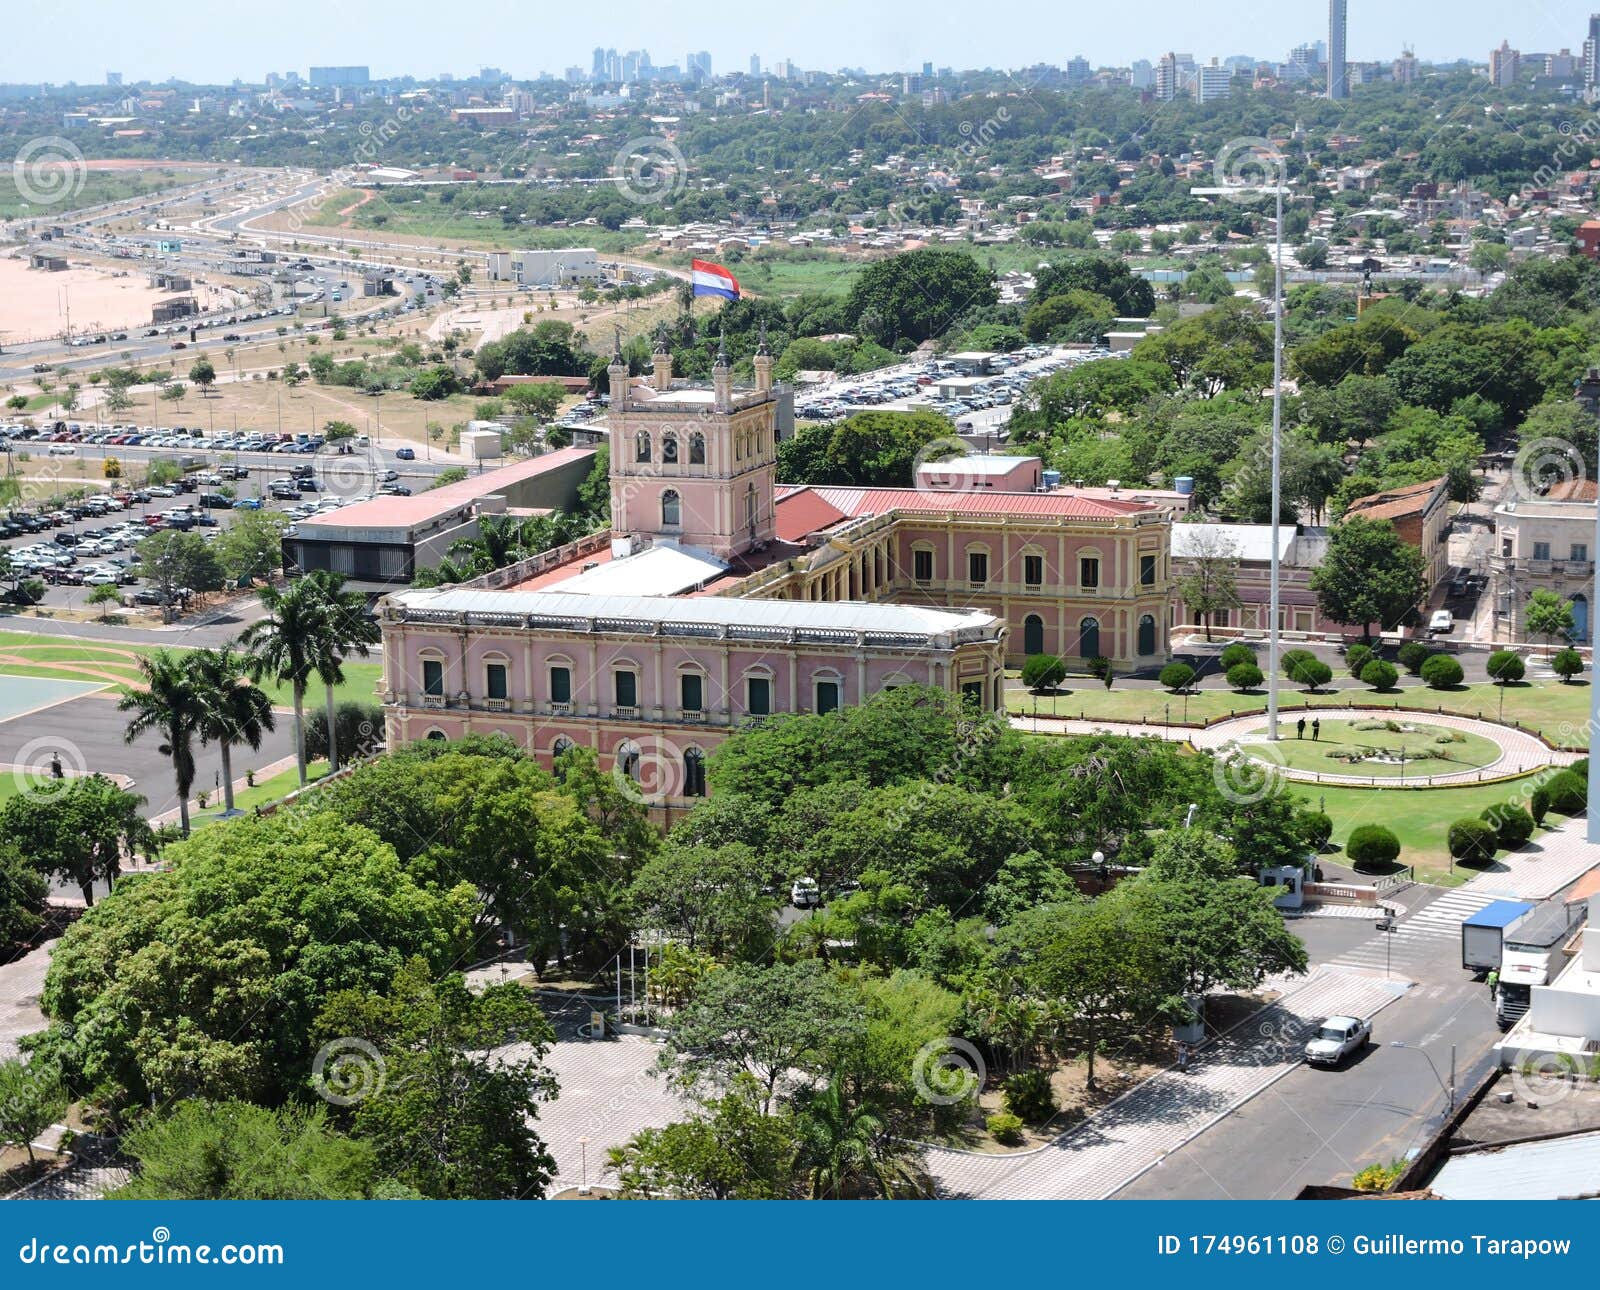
xmin=0 ymin=0 xmax=1600 ymax=83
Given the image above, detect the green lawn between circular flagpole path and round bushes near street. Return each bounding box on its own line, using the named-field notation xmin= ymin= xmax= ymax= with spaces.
xmin=1285 ymin=775 xmax=1562 ymax=887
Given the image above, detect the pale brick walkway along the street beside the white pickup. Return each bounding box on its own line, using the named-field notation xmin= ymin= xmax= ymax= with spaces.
xmin=928 ymin=970 xmax=1408 ymax=1200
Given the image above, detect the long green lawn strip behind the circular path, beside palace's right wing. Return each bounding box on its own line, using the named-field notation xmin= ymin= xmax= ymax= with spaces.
xmin=1006 ymin=677 xmax=1589 ymax=747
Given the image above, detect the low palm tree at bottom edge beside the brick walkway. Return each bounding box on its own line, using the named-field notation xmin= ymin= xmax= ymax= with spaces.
xmin=795 ymin=1079 xmax=925 ymax=1200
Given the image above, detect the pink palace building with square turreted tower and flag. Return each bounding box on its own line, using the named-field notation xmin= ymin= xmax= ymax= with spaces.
xmin=379 ymin=344 xmax=1173 ymax=810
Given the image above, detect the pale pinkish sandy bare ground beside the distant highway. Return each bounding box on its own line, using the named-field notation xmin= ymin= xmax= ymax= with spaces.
xmin=0 ymin=256 xmax=234 ymax=344
